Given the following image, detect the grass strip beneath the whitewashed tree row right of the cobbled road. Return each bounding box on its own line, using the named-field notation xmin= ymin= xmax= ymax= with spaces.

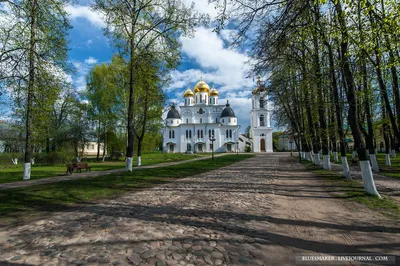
xmin=302 ymin=161 xmax=400 ymax=219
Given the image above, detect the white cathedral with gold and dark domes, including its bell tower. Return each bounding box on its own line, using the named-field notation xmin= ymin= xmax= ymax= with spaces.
xmin=163 ymin=77 xmax=273 ymax=153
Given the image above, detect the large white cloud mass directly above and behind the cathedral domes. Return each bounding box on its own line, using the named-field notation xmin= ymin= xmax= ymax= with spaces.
xmin=166 ymin=27 xmax=256 ymax=132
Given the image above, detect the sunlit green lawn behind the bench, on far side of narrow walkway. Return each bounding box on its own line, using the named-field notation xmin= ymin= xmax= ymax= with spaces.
xmin=0 ymin=153 xmax=208 ymax=184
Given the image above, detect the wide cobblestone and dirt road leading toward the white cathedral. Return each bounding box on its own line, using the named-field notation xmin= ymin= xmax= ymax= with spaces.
xmin=0 ymin=154 xmax=400 ymax=266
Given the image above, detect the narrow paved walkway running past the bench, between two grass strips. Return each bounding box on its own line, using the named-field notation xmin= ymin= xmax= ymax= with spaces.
xmin=0 ymin=153 xmax=228 ymax=190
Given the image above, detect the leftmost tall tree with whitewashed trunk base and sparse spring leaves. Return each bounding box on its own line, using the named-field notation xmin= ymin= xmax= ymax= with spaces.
xmin=0 ymin=0 xmax=70 ymax=180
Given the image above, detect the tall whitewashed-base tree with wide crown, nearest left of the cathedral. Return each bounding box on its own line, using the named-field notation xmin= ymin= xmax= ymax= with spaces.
xmin=93 ymin=0 xmax=195 ymax=171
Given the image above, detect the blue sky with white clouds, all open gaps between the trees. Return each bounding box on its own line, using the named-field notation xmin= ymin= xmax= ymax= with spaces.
xmin=0 ymin=0 xmax=272 ymax=131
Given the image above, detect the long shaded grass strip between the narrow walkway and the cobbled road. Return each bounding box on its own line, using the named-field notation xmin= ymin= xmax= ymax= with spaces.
xmin=0 ymin=154 xmax=253 ymax=225
